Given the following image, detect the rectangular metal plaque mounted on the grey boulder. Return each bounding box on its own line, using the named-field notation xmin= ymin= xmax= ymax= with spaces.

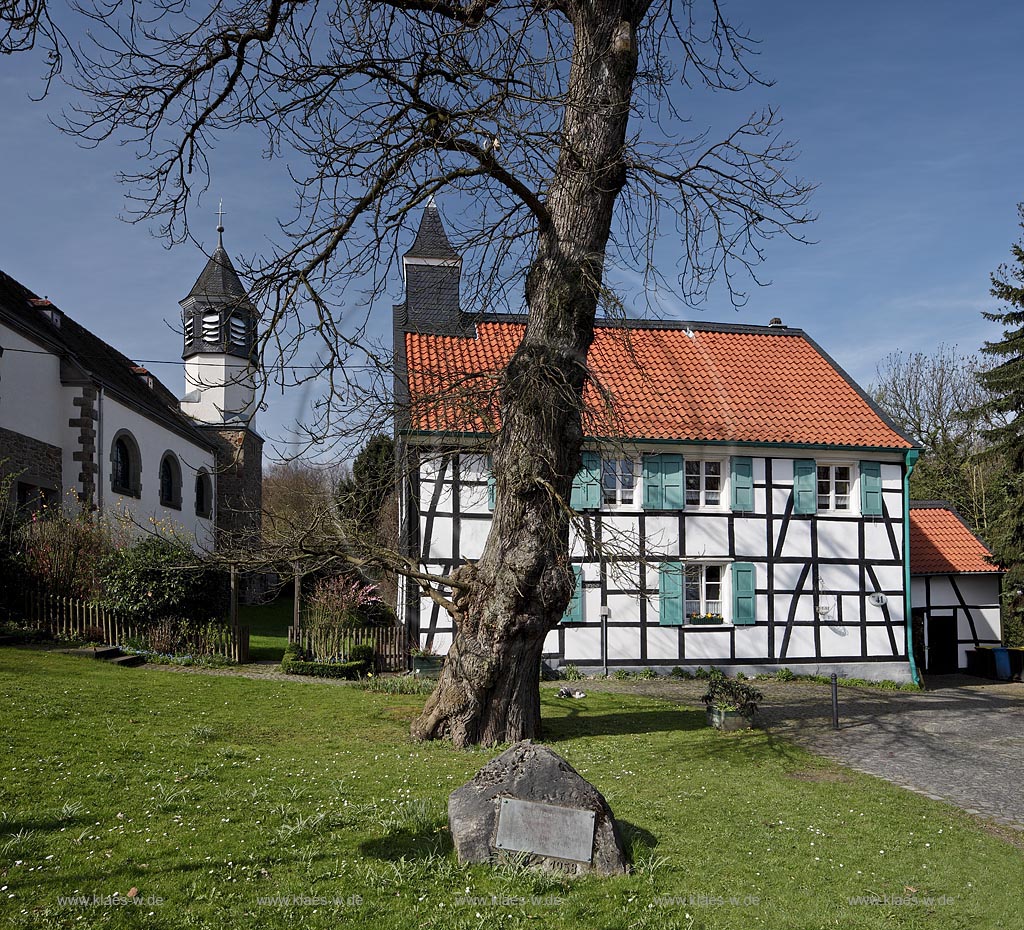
xmin=495 ymin=798 xmax=594 ymax=862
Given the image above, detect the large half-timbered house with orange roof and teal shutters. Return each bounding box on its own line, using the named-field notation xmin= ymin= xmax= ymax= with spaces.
xmin=394 ymin=205 xmax=997 ymax=682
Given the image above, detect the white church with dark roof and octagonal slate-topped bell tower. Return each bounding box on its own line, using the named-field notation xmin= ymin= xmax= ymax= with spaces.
xmin=0 ymin=230 xmax=262 ymax=551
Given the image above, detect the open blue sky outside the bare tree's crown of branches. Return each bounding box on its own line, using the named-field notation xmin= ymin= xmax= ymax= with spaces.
xmin=0 ymin=0 xmax=1024 ymax=456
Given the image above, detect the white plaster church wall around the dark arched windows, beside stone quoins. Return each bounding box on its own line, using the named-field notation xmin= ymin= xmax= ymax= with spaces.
xmin=96 ymin=392 xmax=217 ymax=550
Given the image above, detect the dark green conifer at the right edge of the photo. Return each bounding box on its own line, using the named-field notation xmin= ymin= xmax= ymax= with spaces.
xmin=978 ymin=204 xmax=1024 ymax=645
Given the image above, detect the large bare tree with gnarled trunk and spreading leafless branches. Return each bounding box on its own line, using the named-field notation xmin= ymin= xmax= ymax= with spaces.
xmin=6 ymin=0 xmax=810 ymax=746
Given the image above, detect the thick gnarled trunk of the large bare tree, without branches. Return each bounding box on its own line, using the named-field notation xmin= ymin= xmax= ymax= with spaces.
xmin=412 ymin=0 xmax=640 ymax=747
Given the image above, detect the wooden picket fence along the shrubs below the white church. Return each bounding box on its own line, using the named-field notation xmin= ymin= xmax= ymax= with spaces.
xmin=24 ymin=590 xmax=249 ymax=663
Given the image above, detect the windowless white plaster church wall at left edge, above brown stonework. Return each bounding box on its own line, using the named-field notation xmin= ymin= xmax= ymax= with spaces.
xmin=0 ymin=321 xmax=64 ymax=448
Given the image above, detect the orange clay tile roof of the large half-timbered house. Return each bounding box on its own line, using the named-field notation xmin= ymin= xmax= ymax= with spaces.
xmin=406 ymin=322 xmax=912 ymax=449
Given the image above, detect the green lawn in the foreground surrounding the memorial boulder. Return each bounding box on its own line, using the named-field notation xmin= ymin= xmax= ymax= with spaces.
xmin=0 ymin=648 xmax=1024 ymax=930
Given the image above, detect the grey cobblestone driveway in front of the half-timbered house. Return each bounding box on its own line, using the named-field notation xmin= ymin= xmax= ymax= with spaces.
xmin=584 ymin=676 xmax=1024 ymax=831
